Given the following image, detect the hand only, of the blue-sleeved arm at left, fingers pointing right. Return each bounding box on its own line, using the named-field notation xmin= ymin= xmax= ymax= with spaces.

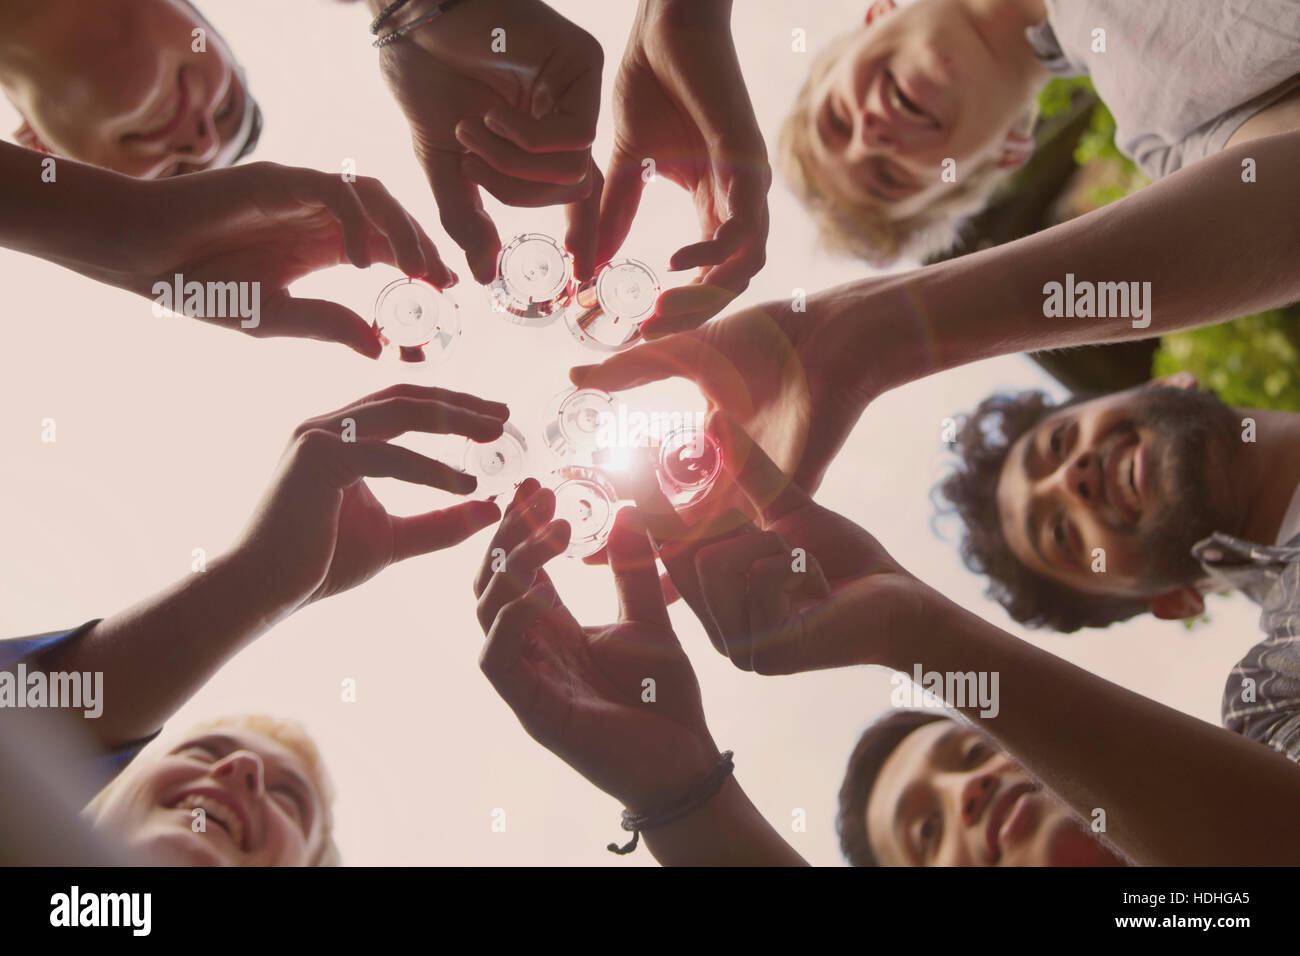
xmin=234 ymin=385 xmax=508 ymax=607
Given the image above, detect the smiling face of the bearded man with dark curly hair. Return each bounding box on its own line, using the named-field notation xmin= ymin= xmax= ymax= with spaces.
xmin=997 ymin=385 xmax=1244 ymax=597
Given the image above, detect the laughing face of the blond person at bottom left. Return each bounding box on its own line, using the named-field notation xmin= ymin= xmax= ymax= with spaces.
xmin=94 ymin=727 xmax=325 ymax=866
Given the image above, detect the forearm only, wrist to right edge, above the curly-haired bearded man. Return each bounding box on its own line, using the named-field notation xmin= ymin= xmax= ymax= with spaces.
xmin=824 ymin=133 xmax=1300 ymax=390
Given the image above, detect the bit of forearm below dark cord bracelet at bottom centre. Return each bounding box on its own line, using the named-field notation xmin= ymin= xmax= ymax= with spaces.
xmin=642 ymin=777 xmax=807 ymax=866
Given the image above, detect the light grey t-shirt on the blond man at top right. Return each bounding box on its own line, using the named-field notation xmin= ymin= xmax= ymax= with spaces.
xmin=1026 ymin=0 xmax=1300 ymax=179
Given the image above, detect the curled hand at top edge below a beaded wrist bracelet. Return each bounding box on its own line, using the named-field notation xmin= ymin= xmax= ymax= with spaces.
xmin=380 ymin=0 xmax=605 ymax=282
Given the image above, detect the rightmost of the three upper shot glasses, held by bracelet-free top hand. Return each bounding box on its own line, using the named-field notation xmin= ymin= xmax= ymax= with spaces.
xmin=564 ymin=259 xmax=659 ymax=352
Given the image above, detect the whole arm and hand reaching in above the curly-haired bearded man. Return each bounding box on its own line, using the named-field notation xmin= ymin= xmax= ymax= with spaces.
xmin=571 ymin=131 xmax=1300 ymax=492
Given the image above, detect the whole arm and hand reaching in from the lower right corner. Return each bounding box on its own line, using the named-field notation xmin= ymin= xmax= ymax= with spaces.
xmin=660 ymin=421 xmax=1300 ymax=866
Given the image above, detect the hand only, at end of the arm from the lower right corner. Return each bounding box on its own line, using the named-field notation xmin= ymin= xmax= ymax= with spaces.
xmin=631 ymin=415 xmax=933 ymax=674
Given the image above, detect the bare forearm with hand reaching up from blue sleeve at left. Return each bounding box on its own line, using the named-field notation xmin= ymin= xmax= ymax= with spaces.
xmin=34 ymin=385 xmax=506 ymax=749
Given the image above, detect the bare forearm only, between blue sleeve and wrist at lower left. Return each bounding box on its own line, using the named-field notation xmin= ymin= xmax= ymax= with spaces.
xmin=35 ymin=548 xmax=291 ymax=748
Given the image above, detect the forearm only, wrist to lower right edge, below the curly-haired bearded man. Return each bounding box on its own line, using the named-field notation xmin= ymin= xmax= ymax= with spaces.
xmin=874 ymin=594 xmax=1300 ymax=866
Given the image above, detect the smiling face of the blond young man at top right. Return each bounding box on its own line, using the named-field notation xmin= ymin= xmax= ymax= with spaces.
xmin=809 ymin=0 xmax=1026 ymax=215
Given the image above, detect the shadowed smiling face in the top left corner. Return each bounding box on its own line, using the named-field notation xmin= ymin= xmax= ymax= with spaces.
xmin=17 ymin=0 xmax=252 ymax=178
